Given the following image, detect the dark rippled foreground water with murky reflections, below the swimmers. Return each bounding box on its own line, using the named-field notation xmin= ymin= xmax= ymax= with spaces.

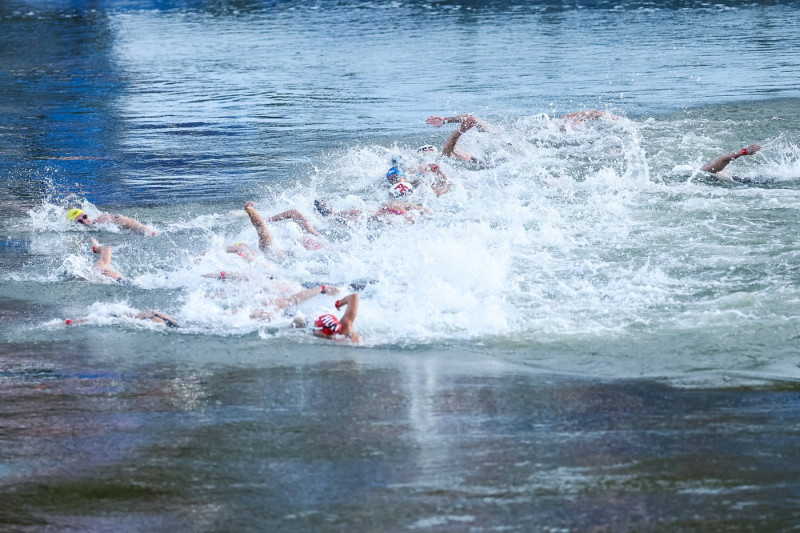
xmin=0 ymin=347 xmax=800 ymax=531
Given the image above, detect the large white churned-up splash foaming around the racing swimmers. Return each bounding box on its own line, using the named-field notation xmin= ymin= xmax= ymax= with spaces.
xmin=17 ymin=111 xmax=798 ymax=358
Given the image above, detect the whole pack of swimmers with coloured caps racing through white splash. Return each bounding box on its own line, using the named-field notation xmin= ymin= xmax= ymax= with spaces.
xmin=66 ymin=111 xmax=761 ymax=343
